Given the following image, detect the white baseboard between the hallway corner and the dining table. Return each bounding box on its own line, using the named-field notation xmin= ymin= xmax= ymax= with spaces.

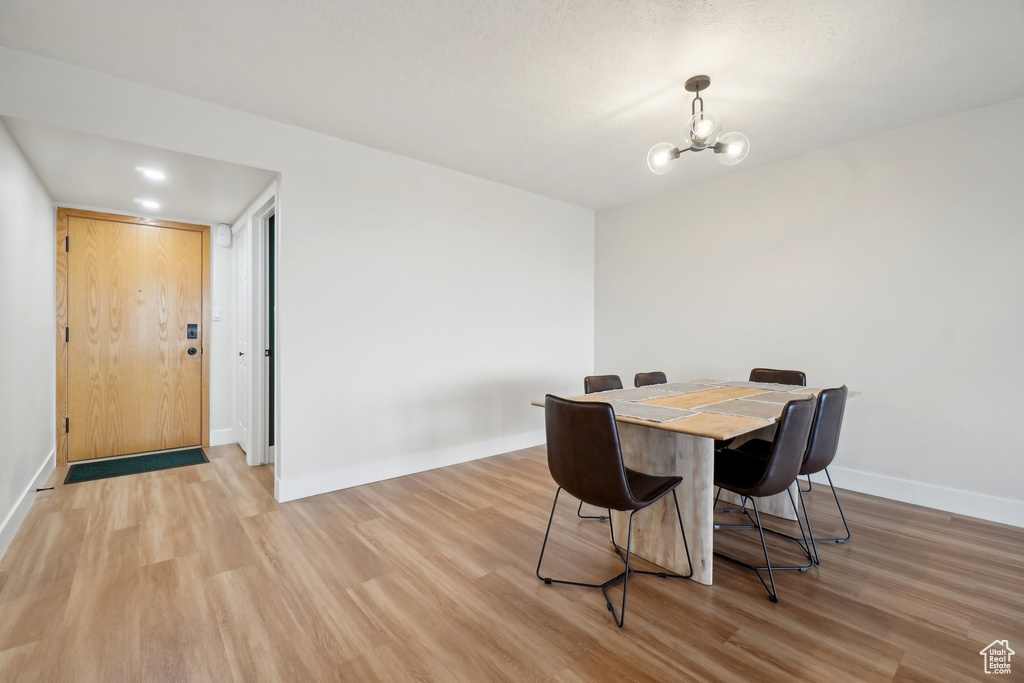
xmin=274 ymin=431 xmax=545 ymax=503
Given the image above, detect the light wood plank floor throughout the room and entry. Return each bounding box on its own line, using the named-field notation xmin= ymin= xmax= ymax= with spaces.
xmin=0 ymin=446 xmax=1024 ymax=681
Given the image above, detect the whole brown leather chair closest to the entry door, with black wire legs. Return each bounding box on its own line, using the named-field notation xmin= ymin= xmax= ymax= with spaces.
xmin=537 ymin=394 xmax=693 ymax=629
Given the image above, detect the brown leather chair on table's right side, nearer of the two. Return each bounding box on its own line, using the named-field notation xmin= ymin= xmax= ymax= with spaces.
xmin=715 ymin=396 xmax=815 ymax=602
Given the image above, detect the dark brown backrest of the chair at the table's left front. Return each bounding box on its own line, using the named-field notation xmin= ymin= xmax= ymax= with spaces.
xmin=544 ymin=394 xmax=635 ymax=510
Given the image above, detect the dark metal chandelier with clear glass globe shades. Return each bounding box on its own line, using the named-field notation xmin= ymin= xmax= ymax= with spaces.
xmin=647 ymin=76 xmax=751 ymax=175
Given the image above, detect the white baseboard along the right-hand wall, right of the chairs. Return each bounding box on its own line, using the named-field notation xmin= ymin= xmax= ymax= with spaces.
xmin=811 ymin=467 xmax=1024 ymax=526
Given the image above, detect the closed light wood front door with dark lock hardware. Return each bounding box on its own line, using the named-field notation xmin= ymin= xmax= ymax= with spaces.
xmin=58 ymin=212 xmax=209 ymax=462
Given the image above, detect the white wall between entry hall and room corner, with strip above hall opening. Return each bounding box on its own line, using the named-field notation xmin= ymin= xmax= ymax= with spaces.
xmin=0 ymin=48 xmax=594 ymax=500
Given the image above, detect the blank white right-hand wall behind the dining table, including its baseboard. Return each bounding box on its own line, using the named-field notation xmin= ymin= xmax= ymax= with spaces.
xmin=595 ymin=99 xmax=1024 ymax=525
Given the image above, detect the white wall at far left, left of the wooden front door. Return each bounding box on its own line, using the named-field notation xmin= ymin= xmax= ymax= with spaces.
xmin=0 ymin=114 xmax=56 ymax=557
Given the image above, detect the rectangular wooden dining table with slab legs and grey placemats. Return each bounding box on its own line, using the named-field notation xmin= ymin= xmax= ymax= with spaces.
xmin=532 ymin=379 xmax=821 ymax=586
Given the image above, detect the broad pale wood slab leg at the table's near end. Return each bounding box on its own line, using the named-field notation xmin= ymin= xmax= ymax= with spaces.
xmin=611 ymin=422 xmax=715 ymax=586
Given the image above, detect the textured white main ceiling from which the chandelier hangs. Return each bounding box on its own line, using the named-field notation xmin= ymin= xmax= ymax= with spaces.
xmin=0 ymin=0 xmax=1024 ymax=207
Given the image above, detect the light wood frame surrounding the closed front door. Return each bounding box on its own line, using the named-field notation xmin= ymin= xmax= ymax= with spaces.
xmin=54 ymin=207 xmax=212 ymax=467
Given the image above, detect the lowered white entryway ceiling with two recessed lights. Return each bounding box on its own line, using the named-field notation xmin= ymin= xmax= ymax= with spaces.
xmin=0 ymin=117 xmax=278 ymax=223
